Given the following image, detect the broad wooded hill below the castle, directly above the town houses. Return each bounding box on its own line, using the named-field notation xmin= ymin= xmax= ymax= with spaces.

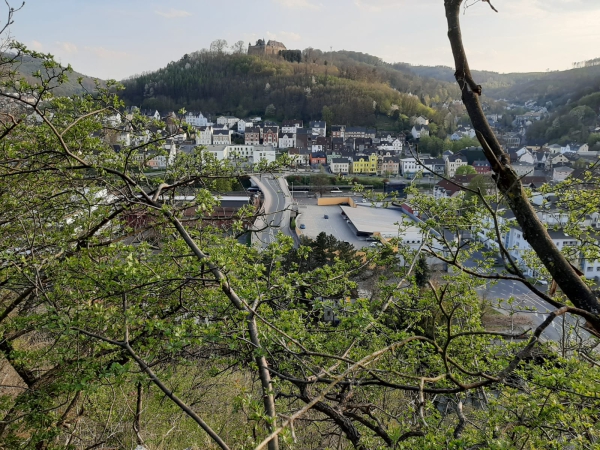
xmin=122 ymin=49 xmax=459 ymax=125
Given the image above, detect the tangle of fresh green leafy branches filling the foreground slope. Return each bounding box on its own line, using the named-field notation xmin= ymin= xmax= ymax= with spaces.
xmin=0 ymin=2 xmax=600 ymax=449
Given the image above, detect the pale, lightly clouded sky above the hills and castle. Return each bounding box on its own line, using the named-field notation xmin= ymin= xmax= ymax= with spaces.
xmin=0 ymin=0 xmax=600 ymax=80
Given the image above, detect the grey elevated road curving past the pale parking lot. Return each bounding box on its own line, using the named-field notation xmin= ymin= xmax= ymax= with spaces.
xmin=251 ymin=175 xmax=298 ymax=248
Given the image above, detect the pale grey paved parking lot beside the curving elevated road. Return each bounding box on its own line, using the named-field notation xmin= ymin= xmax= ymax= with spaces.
xmin=296 ymin=204 xmax=371 ymax=249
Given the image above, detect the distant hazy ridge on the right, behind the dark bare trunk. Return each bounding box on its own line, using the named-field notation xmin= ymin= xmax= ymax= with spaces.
xmin=394 ymin=63 xmax=600 ymax=106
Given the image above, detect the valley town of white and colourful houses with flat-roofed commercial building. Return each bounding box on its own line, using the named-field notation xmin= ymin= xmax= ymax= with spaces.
xmin=95 ymin=104 xmax=600 ymax=283
